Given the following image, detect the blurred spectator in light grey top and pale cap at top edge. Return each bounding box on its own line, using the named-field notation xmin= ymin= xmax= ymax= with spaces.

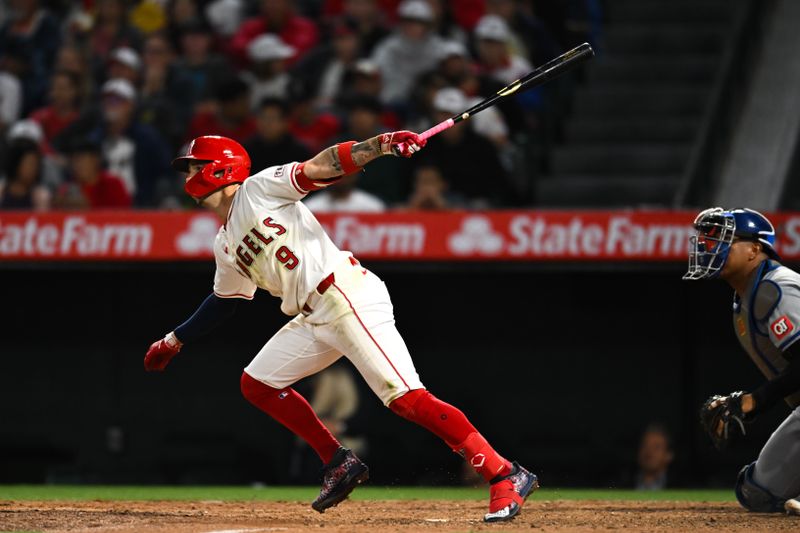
xmin=372 ymin=0 xmax=444 ymax=104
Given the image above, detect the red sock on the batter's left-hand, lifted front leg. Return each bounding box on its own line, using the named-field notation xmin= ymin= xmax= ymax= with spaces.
xmin=241 ymin=372 xmax=341 ymax=464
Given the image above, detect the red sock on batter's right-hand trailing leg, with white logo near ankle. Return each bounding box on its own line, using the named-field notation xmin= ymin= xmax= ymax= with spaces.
xmin=389 ymin=389 xmax=511 ymax=481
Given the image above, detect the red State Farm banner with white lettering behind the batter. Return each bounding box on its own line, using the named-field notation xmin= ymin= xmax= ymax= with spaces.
xmin=0 ymin=211 xmax=800 ymax=262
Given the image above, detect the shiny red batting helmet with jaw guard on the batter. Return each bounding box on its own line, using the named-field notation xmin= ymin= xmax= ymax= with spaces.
xmin=172 ymin=135 xmax=250 ymax=198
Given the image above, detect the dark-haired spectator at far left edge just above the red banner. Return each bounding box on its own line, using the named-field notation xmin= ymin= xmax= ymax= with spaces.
xmin=0 ymin=139 xmax=51 ymax=211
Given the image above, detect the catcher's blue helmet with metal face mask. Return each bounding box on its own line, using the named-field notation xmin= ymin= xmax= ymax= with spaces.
xmin=683 ymin=207 xmax=780 ymax=279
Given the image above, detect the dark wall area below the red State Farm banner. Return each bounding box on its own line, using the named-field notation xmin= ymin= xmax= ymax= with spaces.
xmin=0 ymin=263 xmax=788 ymax=487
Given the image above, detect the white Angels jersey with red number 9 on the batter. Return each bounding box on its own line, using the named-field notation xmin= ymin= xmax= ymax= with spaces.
xmin=214 ymin=162 xmax=351 ymax=315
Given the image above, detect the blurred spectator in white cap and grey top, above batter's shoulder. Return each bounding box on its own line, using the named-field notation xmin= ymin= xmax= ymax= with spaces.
xmin=242 ymin=33 xmax=294 ymax=109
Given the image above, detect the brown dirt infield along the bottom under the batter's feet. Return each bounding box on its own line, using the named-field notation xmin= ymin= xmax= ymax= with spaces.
xmin=0 ymin=500 xmax=800 ymax=533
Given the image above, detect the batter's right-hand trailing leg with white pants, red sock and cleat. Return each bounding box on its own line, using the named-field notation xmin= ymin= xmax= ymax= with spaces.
xmin=317 ymin=274 xmax=538 ymax=522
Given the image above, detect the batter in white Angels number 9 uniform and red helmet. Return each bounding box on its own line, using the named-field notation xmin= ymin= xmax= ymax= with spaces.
xmin=144 ymin=131 xmax=538 ymax=522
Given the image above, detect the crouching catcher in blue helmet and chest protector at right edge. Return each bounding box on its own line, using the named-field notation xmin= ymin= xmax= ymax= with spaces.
xmin=684 ymin=207 xmax=800 ymax=515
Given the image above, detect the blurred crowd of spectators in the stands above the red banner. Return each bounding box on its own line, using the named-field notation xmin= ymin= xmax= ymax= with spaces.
xmin=0 ymin=0 xmax=601 ymax=212
